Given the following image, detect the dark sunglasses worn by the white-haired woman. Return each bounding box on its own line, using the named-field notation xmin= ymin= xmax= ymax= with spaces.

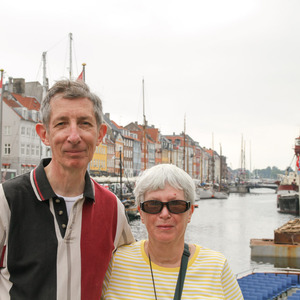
xmin=141 ymin=200 xmax=191 ymax=214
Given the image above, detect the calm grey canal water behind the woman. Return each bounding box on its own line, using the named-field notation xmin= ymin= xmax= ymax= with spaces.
xmin=130 ymin=189 xmax=299 ymax=274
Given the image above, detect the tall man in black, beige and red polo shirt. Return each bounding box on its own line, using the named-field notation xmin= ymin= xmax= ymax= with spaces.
xmin=0 ymin=80 xmax=134 ymax=300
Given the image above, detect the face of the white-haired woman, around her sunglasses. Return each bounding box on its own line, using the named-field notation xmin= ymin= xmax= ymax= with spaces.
xmin=139 ymin=185 xmax=194 ymax=244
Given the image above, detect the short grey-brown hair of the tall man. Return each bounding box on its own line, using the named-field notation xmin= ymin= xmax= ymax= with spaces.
xmin=40 ymin=80 xmax=103 ymax=128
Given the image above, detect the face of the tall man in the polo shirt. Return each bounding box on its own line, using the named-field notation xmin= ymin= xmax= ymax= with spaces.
xmin=40 ymin=95 xmax=106 ymax=170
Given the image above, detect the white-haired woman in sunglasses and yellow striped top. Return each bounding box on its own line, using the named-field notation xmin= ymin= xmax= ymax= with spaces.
xmin=102 ymin=164 xmax=243 ymax=300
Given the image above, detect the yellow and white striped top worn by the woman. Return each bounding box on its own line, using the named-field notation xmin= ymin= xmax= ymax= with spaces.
xmin=101 ymin=241 xmax=243 ymax=300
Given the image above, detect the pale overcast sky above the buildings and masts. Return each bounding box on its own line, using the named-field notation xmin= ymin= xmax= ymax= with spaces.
xmin=0 ymin=0 xmax=300 ymax=169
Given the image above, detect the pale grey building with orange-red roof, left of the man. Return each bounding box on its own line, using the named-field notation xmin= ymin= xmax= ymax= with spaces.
xmin=1 ymin=86 xmax=41 ymax=179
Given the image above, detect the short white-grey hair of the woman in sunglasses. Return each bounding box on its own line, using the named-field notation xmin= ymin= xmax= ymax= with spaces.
xmin=133 ymin=164 xmax=195 ymax=205
